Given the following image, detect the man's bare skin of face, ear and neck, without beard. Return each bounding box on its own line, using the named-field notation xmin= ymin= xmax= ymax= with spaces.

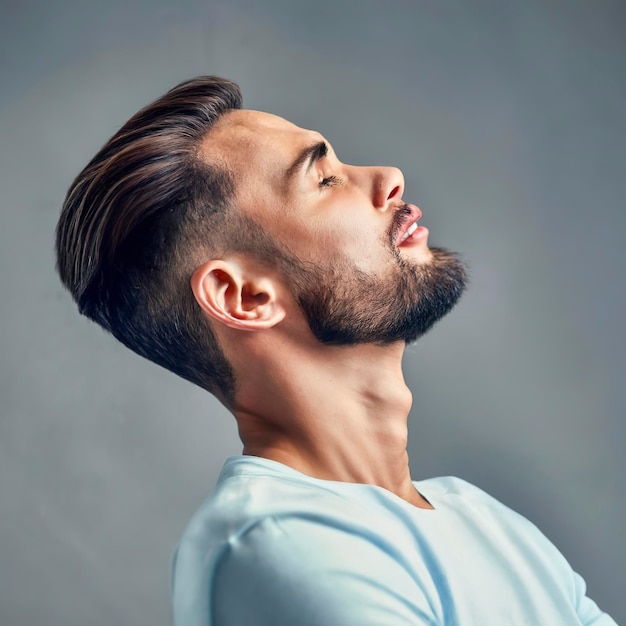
xmin=192 ymin=110 xmax=460 ymax=508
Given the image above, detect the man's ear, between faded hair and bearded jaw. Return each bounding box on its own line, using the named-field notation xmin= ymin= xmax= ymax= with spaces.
xmin=191 ymin=259 xmax=285 ymax=330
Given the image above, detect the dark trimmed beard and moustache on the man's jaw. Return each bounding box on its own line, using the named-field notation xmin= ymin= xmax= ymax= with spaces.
xmin=280 ymin=204 xmax=467 ymax=345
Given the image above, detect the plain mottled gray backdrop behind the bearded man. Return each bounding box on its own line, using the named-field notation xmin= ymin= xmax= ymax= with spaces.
xmin=0 ymin=0 xmax=626 ymax=626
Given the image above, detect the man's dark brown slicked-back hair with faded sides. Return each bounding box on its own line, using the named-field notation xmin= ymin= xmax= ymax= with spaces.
xmin=56 ymin=76 xmax=241 ymax=404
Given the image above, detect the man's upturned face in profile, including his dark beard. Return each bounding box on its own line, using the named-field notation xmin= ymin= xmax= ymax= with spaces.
xmin=200 ymin=110 xmax=465 ymax=344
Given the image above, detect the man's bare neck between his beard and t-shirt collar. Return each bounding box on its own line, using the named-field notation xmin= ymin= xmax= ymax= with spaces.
xmin=234 ymin=344 xmax=431 ymax=508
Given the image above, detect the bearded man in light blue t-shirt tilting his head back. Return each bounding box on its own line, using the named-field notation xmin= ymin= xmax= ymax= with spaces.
xmin=57 ymin=77 xmax=614 ymax=626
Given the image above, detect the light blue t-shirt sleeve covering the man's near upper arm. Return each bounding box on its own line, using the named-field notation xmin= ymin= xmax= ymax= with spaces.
xmin=212 ymin=518 xmax=439 ymax=626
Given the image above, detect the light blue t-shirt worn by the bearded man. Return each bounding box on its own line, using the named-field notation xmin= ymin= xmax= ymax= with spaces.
xmin=172 ymin=456 xmax=615 ymax=626
